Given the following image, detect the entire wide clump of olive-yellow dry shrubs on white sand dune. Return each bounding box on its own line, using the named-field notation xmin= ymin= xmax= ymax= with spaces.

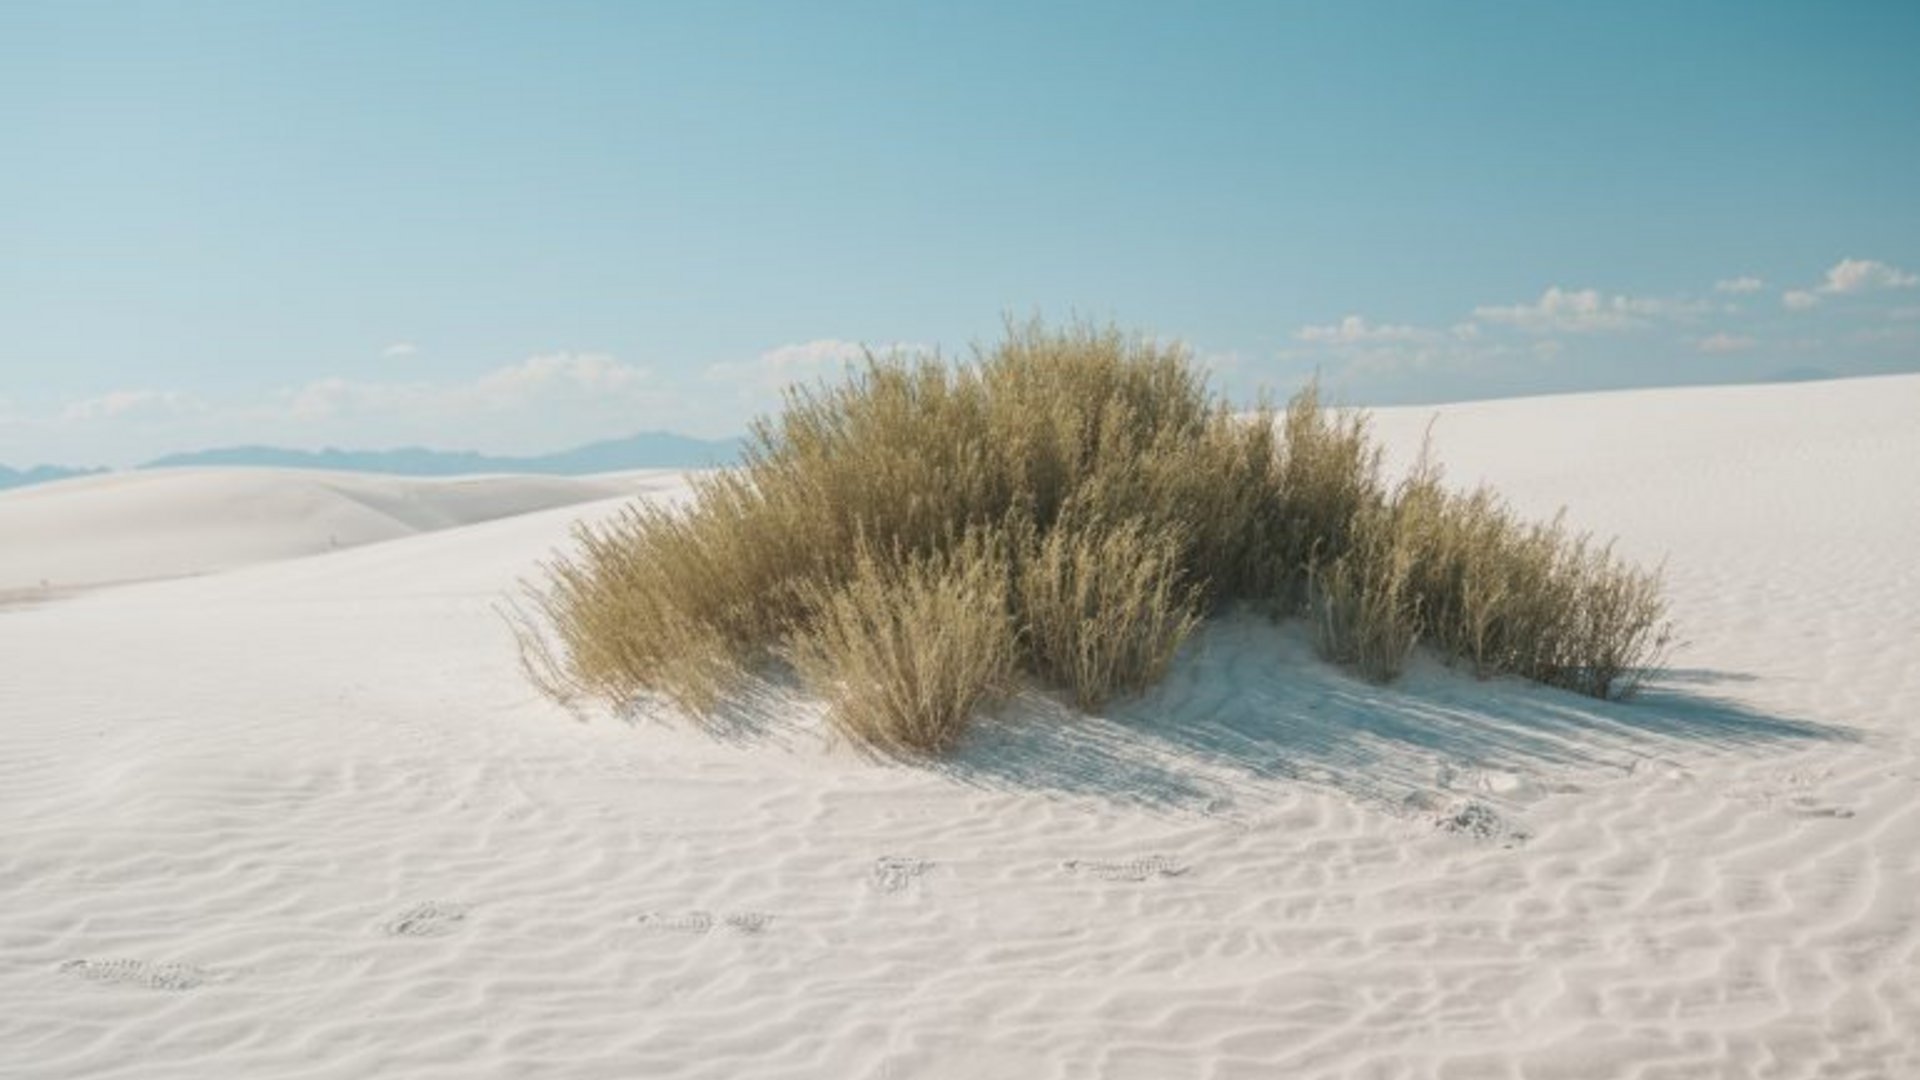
xmin=518 ymin=323 xmax=1668 ymax=753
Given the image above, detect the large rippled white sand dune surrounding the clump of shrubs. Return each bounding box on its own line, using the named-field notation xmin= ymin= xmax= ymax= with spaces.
xmin=0 ymin=377 xmax=1920 ymax=1080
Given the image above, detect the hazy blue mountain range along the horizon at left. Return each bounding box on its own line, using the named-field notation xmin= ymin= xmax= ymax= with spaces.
xmin=0 ymin=430 xmax=741 ymax=488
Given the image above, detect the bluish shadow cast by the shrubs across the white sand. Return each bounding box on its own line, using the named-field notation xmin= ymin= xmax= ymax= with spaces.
xmin=639 ymin=615 xmax=1857 ymax=813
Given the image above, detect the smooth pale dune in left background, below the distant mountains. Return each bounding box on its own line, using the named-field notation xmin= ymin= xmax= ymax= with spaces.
xmin=0 ymin=469 xmax=668 ymax=600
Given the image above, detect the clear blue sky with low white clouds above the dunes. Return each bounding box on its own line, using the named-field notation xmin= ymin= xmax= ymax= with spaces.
xmin=0 ymin=0 xmax=1920 ymax=465
